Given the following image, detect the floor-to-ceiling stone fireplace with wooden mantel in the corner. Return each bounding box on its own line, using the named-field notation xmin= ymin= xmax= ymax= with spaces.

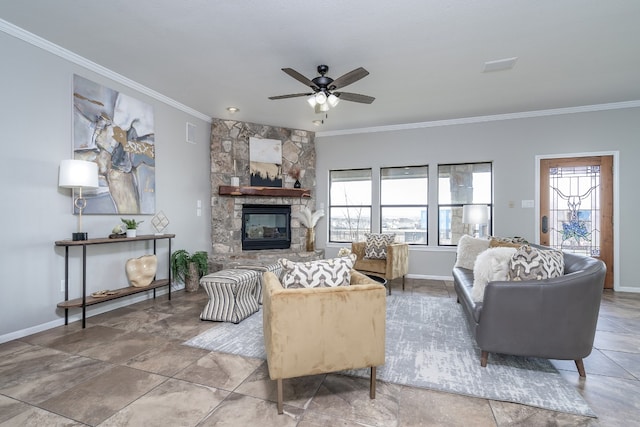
xmin=209 ymin=119 xmax=323 ymax=271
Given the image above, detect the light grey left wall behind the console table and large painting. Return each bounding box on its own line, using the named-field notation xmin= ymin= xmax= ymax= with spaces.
xmin=0 ymin=32 xmax=211 ymax=342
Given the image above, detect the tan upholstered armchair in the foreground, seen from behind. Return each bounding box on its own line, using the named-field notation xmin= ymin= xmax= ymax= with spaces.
xmin=262 ymin=270 xmax=386 ymax=414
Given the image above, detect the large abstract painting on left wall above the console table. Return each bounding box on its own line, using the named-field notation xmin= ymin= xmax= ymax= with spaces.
xmin=73 ymin=75 xmax=156 ymax=214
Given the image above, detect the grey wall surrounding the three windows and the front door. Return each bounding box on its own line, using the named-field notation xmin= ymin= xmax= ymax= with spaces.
xmin=316 ymin=108 xmax=640 ymax=292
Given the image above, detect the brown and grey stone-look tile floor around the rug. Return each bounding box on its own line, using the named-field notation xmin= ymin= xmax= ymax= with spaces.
xmin=0 ymin=279 xmax=640 ymax=427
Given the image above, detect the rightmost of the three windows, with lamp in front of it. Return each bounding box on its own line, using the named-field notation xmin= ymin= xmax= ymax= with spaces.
xmin=438 ymin=163 xmax=493 ymax=245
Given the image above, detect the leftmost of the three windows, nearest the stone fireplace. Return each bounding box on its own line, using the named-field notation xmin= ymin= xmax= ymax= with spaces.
xmin=329 ymin=169 xmax=371 ymax=242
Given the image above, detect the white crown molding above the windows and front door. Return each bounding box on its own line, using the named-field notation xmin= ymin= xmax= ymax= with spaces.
xmin=316 ymin=100 xmax=640 ymax=138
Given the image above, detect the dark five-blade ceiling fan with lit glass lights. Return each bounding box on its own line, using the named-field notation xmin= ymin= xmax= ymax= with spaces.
xmin=269 ymin=65 xmax=375 ymax=113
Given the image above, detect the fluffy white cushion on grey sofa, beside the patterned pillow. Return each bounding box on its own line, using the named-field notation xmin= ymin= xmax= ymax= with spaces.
xmin=471 ymin=247 xmax=516 ymax=302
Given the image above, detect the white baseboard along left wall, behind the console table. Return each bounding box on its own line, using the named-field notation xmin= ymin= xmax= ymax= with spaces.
xmin=0 ymin=284 xmax=184 ymax=344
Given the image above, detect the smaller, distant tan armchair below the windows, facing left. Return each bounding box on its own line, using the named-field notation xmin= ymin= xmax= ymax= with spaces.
xmin=351 ymin=242 xmax=409 ymax=293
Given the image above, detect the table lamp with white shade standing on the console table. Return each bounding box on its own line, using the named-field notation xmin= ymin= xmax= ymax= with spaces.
xmin=58 ymin=160 xmax=98 ymax=240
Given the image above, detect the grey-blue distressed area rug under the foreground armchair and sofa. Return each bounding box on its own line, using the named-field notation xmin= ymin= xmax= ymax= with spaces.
xmin=184 ymin=293 xmax=595 ymax=417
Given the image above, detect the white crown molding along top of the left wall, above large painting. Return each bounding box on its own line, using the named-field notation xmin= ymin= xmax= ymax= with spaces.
xmin=0 ymin=19 xmax=211 ymax=123
